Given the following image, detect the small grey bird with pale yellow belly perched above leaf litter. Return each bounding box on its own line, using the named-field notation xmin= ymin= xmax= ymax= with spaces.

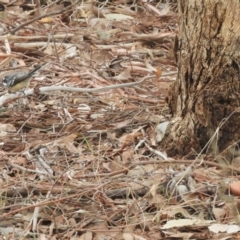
xmin=2 ymin=63 xmax=46 ymax=93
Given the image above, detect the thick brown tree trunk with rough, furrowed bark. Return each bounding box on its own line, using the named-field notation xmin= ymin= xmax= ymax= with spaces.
xmin=162 ymin=0 xmax=240 ymax=156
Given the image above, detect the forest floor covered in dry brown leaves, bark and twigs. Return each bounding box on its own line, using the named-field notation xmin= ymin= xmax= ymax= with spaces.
xmin=0 ymin=0 xmax=239 ymax=240
